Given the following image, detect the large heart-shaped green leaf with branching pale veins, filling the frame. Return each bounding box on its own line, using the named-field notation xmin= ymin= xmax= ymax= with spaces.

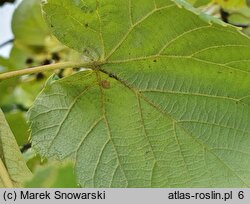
xmin=29 ymin=0 xmax=250 ymax=187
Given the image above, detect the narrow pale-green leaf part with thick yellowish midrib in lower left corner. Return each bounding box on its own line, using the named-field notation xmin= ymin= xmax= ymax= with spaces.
xmin=0 ymin=110 xmax=31 ymax=187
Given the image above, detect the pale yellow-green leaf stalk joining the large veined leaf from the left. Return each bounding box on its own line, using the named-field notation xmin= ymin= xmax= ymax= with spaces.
xmin=0 ymin=62 xmax=93 ymax=81
